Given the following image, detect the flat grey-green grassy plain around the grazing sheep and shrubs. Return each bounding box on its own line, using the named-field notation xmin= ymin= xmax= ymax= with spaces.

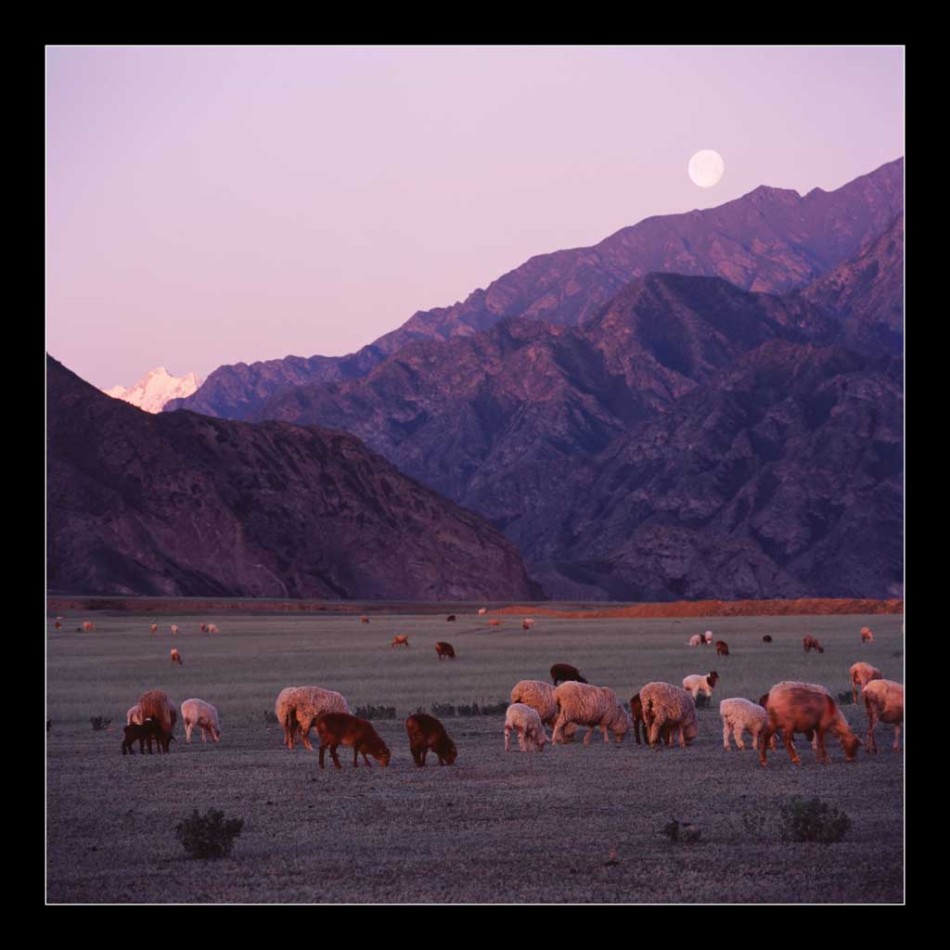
xmin=47 ymin=605 xmax=904 ymax=903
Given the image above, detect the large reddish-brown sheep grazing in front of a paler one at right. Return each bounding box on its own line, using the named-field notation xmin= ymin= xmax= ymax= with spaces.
xmin=759 ymin=681 xmax=861 ymax=765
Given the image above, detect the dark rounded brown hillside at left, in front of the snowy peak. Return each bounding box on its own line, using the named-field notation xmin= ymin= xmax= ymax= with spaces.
xmin=47 ymin=359 xmax=539 ymax=600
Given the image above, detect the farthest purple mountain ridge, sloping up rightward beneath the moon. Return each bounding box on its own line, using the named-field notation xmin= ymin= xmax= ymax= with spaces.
xmin=166 ymin=159 xmax=904 ymax=419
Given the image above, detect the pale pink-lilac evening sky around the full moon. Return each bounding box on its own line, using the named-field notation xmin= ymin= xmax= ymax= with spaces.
xmin=46 ymin=46 xmax=904 ymax=388
